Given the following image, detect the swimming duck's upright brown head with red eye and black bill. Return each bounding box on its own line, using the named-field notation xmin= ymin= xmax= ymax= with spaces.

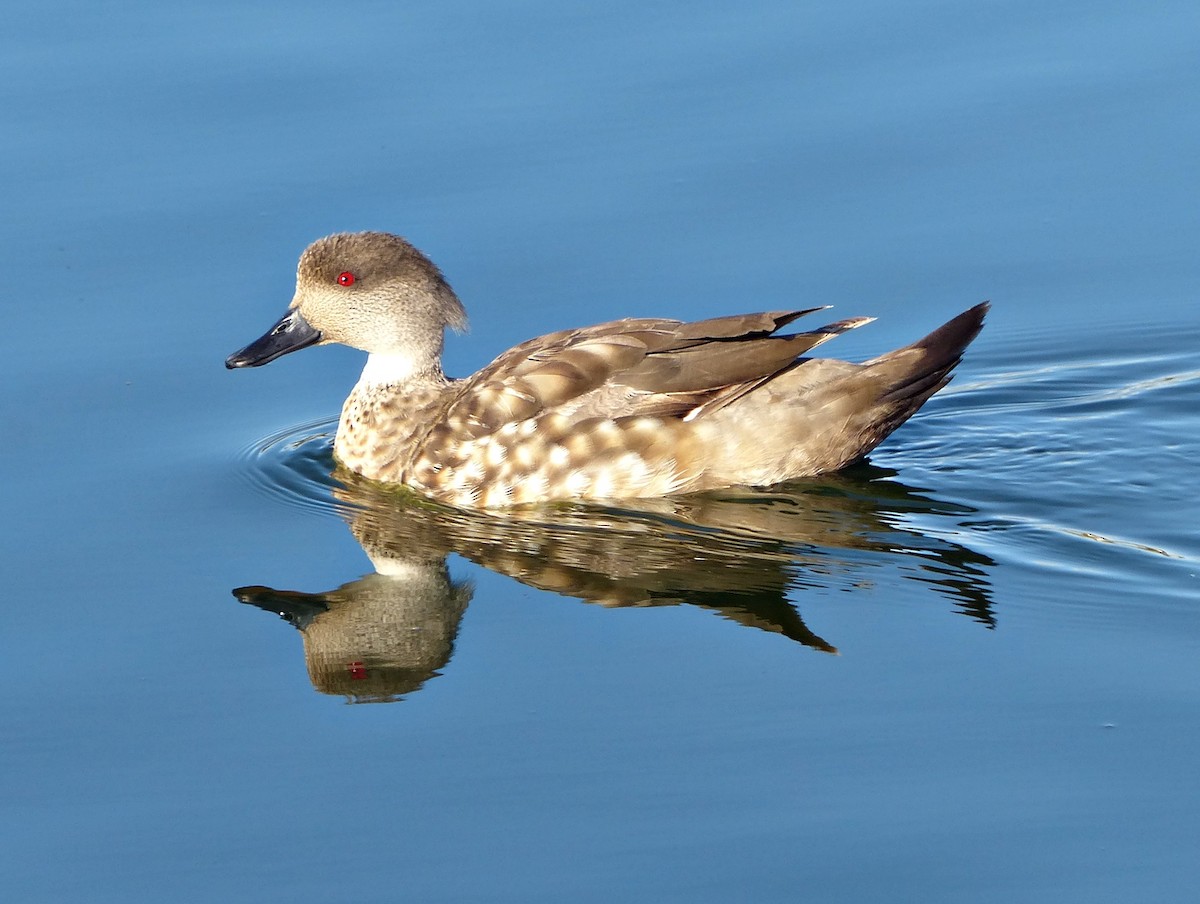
xmin=226 ymin=232 xmax=467 ymax=372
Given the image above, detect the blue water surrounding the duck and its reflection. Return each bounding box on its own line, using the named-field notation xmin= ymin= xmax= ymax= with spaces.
xmin=0 ymin=0 xmax=1200 ymax=902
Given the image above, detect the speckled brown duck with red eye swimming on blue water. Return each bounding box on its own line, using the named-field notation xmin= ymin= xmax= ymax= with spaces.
xmin=226 ymin=232 xmax=989 ymax=508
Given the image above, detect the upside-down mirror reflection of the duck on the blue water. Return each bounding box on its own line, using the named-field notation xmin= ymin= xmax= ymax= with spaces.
xmin=234 ymin=465 xmax=992 ymax=702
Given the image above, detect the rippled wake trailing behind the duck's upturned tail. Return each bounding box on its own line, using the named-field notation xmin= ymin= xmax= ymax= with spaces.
xmin=875 ymin=330 xmax=1200 ymax=605
